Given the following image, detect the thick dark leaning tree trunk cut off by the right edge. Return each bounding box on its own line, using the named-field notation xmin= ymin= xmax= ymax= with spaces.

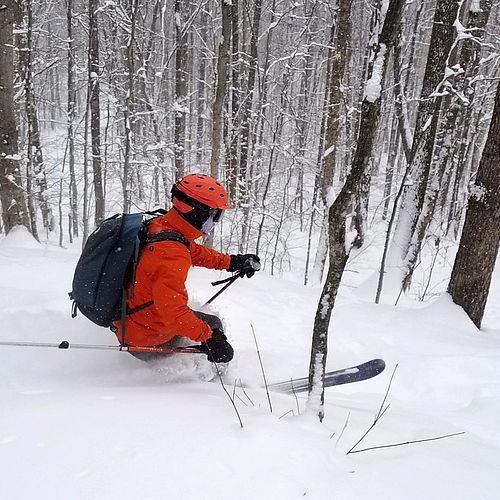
xmin=448 ymin=78 xmax=500 ymax=328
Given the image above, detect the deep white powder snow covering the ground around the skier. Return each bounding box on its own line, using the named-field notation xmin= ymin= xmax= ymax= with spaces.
xmin=0 ymin=231 xmax=500 ymax=500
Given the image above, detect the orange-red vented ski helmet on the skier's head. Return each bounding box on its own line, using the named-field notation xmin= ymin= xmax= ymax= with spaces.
xmin=172 ymin=174 xmax=229 ymax=212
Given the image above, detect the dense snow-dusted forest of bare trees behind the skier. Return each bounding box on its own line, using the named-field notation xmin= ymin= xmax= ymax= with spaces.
xmin=0 ymin=0 xmax=500 ymax=416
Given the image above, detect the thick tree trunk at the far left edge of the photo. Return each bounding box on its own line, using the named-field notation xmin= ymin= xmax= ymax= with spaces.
xmin=0 ymin=0 xmax=28 ymax=233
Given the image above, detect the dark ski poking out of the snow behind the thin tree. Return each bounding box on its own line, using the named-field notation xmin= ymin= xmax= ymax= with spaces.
xmin=269 ymin=359 xmax=385 ymax=394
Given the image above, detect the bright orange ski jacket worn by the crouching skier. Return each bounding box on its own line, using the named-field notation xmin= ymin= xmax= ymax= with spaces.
xmin=114 ymin=208 xmax=231 ymax=346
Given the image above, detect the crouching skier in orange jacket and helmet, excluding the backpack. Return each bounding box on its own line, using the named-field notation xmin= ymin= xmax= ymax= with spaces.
xmin=114 ymin=174 xmax=260 ymax=363
